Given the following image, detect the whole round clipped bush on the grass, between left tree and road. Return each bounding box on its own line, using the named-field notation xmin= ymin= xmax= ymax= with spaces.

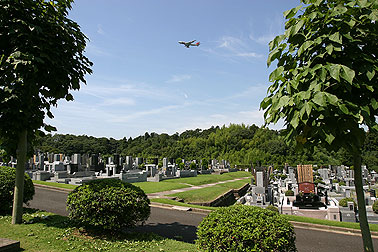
xmin=67 ymin=179 xmax=150 ymax=230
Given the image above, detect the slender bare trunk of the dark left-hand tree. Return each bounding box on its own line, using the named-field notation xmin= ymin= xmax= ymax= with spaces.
xmin=12 ymin=130 xmax=27 ymax=224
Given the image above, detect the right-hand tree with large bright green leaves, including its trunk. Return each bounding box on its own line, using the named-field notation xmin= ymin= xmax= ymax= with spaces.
xmin=261 ymin=0 xmax=378 ymax=251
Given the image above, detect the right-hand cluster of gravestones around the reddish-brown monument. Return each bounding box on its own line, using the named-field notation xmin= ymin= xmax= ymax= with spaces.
xmin=238 ymin=165 xmax=378 ymax=224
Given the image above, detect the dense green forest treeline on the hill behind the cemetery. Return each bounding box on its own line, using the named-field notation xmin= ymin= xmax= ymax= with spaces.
xmin=36 ymin=124 xmax=378 ymax=171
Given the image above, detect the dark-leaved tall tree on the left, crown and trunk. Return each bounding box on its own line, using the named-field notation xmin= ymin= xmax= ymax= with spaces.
xmin=0 ymin=0 xmax=92 ymax=224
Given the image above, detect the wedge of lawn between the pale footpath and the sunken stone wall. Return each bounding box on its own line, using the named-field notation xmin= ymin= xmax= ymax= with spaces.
xmin=169 ymin=179 xmax=250 ymax=202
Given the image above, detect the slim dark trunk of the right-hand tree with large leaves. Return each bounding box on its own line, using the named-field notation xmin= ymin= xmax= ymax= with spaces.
xmin=353 ymin=152 xmax=374 ymax=252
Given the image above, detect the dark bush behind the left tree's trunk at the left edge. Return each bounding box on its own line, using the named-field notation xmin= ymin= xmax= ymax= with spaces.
xmin=0 ymin=166 xmax=34 ymax=214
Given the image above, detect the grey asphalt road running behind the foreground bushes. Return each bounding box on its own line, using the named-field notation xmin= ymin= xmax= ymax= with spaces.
xmin=30 ymin=187 xmax=378 ymax=252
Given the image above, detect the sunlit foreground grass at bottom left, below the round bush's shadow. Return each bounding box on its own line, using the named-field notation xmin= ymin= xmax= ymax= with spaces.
xmin=0 ymin=210 xmax=197 ymax=252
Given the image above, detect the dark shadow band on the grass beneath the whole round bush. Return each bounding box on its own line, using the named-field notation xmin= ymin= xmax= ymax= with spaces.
xmin=23 ymin=208 xmax=192 ymax=243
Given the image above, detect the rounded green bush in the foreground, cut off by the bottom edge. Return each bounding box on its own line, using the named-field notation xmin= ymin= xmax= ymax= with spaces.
xmin=196 ymin=205 xmax=296 ymax=251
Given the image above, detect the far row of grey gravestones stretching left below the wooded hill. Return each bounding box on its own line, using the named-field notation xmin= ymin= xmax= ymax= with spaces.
xmin=0 ymin=153 xmax=233 ymax=185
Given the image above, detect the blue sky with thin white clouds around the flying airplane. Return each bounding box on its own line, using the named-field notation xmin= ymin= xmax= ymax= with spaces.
xmin=46 ymin=0 xmax=300 ymax=139
